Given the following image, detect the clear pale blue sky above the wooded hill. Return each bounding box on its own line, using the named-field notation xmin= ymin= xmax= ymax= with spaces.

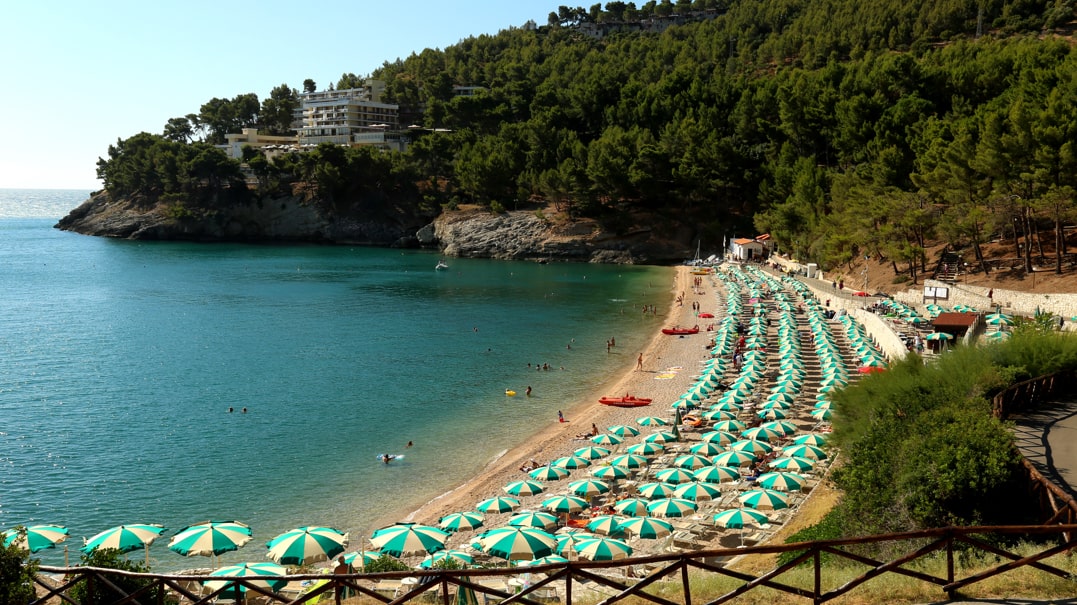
xmin=0 ymin=0 xmax=555 ymax=189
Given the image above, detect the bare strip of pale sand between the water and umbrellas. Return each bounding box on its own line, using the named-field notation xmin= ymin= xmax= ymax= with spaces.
xmin=392 ymin=266 xmax=702 ymax=531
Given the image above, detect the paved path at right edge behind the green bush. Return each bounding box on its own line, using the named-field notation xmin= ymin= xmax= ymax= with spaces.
xmin=1011 ymin=393 xmax=1077 ymax=498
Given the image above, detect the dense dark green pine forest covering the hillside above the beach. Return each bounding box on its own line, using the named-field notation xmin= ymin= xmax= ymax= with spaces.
xmin=101 ymin=0 xmax=1077 ymax=265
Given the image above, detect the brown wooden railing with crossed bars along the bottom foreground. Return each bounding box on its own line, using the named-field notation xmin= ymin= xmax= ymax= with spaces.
xmin=30 ymin=525 xmax=1077 ymax=605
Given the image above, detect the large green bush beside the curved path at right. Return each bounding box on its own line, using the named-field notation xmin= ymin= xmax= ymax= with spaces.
xmin=791 ymin=322 xmax=1077 ymax=541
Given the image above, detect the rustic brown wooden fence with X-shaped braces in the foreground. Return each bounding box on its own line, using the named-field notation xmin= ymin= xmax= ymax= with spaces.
xmin=30 ymin=524 xmax=1077 ymax=605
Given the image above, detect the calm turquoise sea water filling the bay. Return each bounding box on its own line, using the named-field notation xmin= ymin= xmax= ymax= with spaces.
xmin=0 ymin=189 xmax=673 ymax=572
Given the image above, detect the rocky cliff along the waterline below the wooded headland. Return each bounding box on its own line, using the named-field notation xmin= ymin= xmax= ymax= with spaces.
xmin=56 ymin=193 xmax=690 ymax=264
